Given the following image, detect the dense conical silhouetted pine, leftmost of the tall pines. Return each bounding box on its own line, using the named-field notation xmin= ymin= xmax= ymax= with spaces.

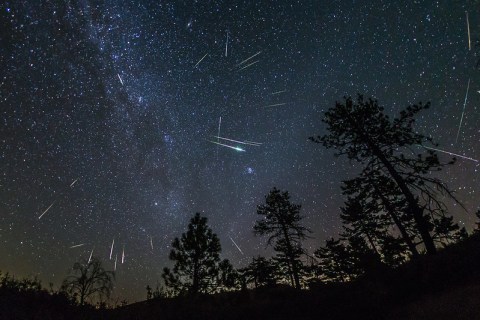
xmin=162 ymin=213 xmax=221 ymax=295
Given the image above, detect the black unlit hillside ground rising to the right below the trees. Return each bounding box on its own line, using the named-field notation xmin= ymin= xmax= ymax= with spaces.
xmin=0 ymin=234 xmax=480 ymax=320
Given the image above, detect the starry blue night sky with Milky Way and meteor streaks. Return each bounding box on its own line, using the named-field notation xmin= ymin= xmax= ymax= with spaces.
xmin=0 ymin=0 xmax=480 ymax=302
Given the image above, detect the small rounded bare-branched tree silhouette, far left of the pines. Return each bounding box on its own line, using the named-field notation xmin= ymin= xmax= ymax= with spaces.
xmin=61 ymin=258 xmax=115 ymax=305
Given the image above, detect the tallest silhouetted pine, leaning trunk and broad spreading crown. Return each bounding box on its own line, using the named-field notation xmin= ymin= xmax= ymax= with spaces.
xmin=310 ymin=95 xmax=464 ymax=254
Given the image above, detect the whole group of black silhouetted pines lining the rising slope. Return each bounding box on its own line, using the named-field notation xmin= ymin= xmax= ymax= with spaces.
xmin=152 ymin=95 xmax=474 ymax=297
